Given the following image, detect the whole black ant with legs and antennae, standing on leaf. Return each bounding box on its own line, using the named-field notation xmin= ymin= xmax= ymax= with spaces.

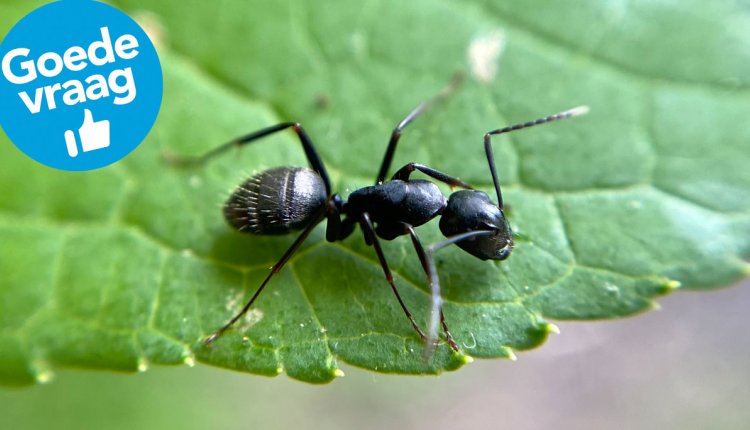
xmin=168 ymin=77 xmax=588 ymax=357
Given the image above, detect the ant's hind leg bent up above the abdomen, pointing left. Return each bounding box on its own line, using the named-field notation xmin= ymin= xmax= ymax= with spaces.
xmin=164 ymin=122 xmax=331 ymax=196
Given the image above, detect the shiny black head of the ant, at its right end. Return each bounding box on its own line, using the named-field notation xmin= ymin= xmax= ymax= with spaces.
xmin=440 ymin=190 xmax=513 ymax=260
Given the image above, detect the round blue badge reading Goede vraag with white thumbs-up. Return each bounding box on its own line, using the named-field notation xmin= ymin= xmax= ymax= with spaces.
xmin=0 ymin=0 xmax=163 ymax=170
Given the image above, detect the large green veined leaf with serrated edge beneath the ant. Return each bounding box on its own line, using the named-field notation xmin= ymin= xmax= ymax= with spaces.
xmin=0 ymin=0 xmax=750 ymax=384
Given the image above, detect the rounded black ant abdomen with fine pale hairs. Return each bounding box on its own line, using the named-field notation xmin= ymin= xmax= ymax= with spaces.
xmin=224 ymin=167 xmax=328 ymax=235
